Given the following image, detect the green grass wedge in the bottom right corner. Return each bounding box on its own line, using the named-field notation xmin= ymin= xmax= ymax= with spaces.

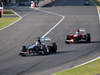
xmin=53 ymin=59 xmax=100 ymax=75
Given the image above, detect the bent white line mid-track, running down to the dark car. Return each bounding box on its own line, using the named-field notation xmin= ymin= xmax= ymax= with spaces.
xmin=34 ymin=8 xmax=65 ymax=38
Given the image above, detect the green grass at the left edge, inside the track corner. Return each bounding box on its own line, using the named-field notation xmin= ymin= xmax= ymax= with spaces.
xmin=0 ymin=11 xmax=19 ymax=29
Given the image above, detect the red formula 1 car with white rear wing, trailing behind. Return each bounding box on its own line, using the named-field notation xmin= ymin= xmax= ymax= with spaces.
xmin=65 ymin=29 xmax=91 ymax=44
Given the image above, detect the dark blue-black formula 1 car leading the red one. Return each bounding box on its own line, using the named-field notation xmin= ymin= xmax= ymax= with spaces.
xmin=19 ymin=37 xmax=57 ymax=56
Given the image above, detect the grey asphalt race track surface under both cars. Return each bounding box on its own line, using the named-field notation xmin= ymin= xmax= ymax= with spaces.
xmin=0 ymin=0 xmax=100 ymax=75
